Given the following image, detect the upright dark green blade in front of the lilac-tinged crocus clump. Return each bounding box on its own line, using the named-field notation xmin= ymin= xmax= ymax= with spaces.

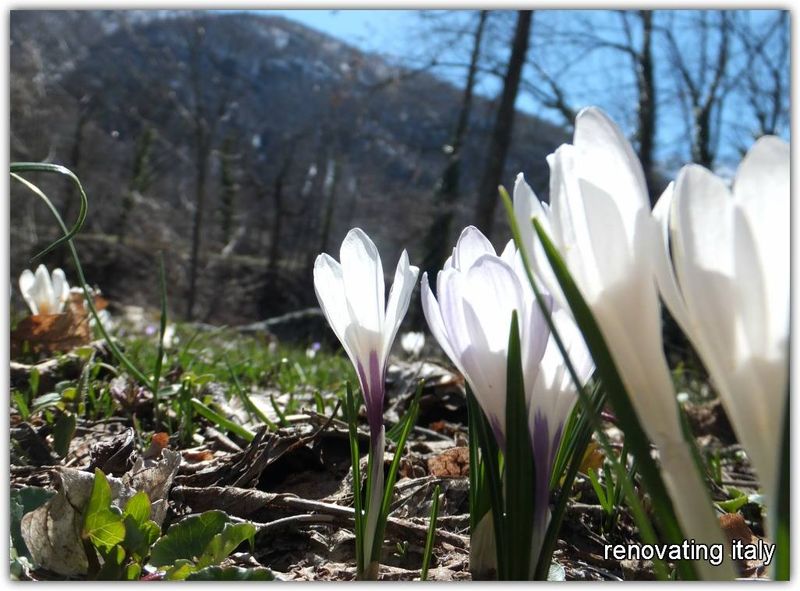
xmin=501 ymin=310 xmax=536 ymax=581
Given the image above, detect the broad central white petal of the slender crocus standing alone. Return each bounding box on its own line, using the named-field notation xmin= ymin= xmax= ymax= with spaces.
xmin=339 ymin=228 xmax=386 ymax=334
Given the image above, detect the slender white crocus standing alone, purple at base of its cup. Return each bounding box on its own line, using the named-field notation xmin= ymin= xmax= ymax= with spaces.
xmin=314 ymin=228 xmax=419 ymax=568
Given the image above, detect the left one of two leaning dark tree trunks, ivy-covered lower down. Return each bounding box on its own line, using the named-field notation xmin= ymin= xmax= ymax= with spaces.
xmin=422 ymin=10 xmax=489 ymax=274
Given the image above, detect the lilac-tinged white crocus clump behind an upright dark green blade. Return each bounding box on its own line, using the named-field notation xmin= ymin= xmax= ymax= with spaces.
xmin=422 ymin=226 xmax=594 ymax=563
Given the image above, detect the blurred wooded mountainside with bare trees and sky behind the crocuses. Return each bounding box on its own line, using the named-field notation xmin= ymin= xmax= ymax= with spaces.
xmin=9 ymin=10 xmax=790 ymax=324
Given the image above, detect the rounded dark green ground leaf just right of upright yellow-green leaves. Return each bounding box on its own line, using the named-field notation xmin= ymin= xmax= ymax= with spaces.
xmin=150 ymin=511 xmax=229 ymax=566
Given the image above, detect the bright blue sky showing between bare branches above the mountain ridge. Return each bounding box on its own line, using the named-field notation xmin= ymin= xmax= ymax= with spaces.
xmin=259 ymin=9 xmax=788 ymax=168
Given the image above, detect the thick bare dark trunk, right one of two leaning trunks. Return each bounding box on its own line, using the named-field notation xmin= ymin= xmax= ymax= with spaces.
xmin=475 ymin=10 xmax=533 ymax=237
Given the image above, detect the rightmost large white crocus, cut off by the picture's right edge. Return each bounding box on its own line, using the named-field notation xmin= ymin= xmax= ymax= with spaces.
xmin=655 ymin=136 xmax=790 ymax=535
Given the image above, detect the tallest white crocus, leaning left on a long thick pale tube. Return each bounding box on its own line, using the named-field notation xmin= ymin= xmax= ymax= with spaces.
xmin=514 ymin=108 xmax=734 ymax=578
